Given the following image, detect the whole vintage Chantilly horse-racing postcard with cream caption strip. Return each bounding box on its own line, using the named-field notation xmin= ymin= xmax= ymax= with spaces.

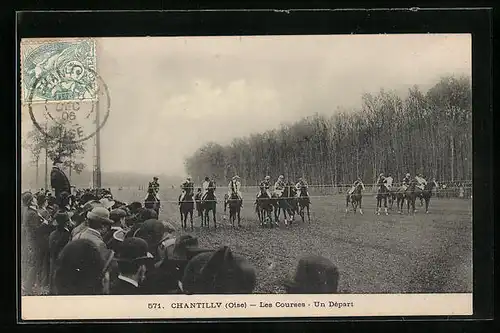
xmin=19 ymin=34 xmax=473 ymax=320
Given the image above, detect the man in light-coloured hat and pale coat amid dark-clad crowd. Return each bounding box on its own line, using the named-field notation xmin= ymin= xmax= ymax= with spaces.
xmin=74 ymin=207 xmax=113 ymax=251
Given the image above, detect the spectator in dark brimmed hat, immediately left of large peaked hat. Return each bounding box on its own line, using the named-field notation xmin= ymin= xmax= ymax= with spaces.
xmin=141 ymin=235 xmax=213 ymax=295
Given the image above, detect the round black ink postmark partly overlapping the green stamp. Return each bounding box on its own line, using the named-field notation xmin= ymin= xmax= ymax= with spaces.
xmin=27 ymin=61 xmax=111 ymax=143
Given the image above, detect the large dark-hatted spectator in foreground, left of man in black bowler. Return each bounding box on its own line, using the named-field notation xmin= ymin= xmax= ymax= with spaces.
xmin=54 ymin=239 xmax=114 ymax=295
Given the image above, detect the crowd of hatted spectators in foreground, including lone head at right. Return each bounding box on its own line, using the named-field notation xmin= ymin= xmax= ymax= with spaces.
xmin=21 ymin=189 xmax=339 ymax=295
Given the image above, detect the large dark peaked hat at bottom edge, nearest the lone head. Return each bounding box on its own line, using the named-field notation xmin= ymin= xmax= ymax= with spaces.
xmin=180 ymin=246 xmax=256 ymax=294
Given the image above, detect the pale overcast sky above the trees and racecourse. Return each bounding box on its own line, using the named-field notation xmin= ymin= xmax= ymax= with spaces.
xmin=23 ymin=35 xmax=471 ymax=175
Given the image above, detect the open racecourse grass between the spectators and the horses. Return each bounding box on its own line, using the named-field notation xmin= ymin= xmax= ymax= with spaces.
xmin=112 ymin=189 xmax=472 ymax=293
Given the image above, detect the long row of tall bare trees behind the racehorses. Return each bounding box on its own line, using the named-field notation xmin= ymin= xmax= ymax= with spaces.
xmin=185 ymin=76 xmax=472 ymax=186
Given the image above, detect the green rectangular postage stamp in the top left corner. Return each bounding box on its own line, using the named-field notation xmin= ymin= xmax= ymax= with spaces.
xmin=21 ymin=38 xmax=97 ymax=103
